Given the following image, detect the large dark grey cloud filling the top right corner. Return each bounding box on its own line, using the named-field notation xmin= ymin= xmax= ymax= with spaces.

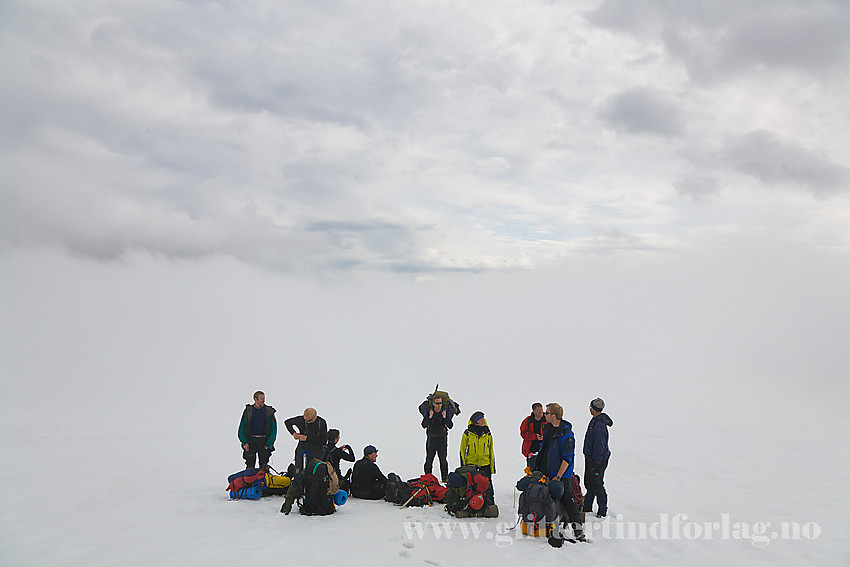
xmin=587 ymin=0 xmax=850 ymax=81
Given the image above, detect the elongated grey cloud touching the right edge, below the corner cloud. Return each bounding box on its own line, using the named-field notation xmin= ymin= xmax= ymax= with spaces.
xmin=722 ymin=130 xmax=850 ymax=196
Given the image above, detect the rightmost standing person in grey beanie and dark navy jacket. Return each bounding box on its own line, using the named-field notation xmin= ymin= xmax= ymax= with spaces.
xmin=584 ymin=398 xmax=614 ymax=518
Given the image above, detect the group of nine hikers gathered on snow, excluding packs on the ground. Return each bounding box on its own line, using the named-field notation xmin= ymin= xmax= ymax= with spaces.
xmin=238 ymin=391 xmax=613 ymax=535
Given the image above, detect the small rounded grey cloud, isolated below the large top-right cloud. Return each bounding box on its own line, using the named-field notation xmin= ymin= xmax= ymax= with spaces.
xmin=600 ymin=87 xmax=684 ymax=136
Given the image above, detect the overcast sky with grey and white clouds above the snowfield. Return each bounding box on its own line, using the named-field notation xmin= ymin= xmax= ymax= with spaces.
xmin=0 ymin=0 xmax=850 ymax=274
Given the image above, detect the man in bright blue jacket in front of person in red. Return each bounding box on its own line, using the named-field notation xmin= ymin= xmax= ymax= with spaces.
xmin=534 ymin=403 xmax=585 ymax=541
